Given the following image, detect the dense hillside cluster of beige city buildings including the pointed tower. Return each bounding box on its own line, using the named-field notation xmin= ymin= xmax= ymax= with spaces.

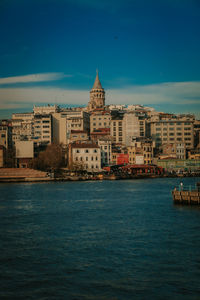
xmin=0 ymin=72 xmax=200 ymax=172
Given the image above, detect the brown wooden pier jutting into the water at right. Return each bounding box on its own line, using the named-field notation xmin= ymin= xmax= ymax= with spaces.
xmin=172 ymin=189 xmax=200 ymax=205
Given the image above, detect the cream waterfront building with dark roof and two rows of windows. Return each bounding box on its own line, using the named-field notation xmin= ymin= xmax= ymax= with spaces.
xmin=68 ymin=143 xmax=101 ymax=172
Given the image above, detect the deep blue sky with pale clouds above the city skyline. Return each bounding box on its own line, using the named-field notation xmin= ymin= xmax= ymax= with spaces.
xmin=0 ymin=0 xmax=200 ymax=118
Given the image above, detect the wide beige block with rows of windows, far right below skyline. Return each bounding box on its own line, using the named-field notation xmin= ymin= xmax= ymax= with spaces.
xmin=149 ymin=114 xmax=195 ymax=149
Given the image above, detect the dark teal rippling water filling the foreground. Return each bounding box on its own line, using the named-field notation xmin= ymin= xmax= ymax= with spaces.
xmin=0 ymin=178 xmax=200 ymax=300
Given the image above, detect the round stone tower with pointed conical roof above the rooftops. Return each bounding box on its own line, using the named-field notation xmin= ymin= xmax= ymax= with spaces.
xmin=88 ymin=72 xmax=105 ymax=111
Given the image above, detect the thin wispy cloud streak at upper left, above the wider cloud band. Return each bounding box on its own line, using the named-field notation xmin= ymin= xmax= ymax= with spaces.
xmin=0 ymin=73 xmax=71 ymax=84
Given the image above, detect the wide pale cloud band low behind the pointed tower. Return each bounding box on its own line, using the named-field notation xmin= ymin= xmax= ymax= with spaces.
xmin=0 ymin=81 xmax=200 ymax=113
